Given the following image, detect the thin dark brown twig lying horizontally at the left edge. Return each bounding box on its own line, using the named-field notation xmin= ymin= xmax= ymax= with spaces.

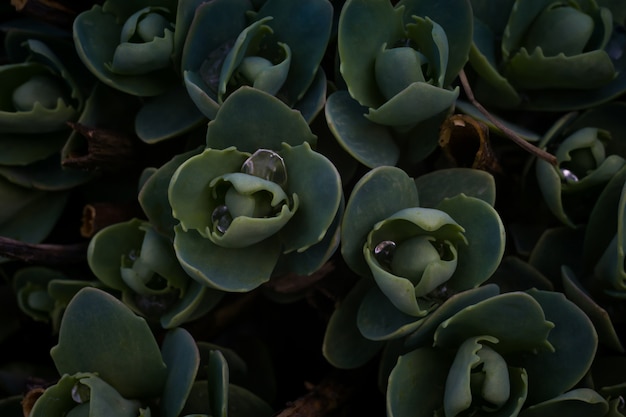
xmin=0 ymin=236 xmax=88 ymax=265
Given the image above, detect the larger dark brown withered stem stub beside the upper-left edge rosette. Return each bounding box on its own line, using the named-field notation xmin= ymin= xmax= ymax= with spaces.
xmin=62 ymin=122 xmax=137 ymax=172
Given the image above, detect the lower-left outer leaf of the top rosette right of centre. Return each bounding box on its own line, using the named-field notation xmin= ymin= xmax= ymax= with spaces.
xmin=325 ymin=91 xmax=400 ymax=168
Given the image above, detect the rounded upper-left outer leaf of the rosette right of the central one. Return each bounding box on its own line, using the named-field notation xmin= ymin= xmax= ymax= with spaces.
xmin=341 ymin=167 xmax=419 ymax=276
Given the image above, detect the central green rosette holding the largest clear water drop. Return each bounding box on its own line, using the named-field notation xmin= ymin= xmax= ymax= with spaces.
xmin=168 ymin=87 xmax=343 ymax=291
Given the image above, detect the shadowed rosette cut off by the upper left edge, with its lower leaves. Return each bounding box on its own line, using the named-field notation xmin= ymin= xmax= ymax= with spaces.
xmin=0 ymin=28 xmax=89 ymax=250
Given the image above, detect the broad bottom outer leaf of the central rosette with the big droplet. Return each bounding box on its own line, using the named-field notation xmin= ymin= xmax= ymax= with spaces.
xmin=174 ymin=226 xmax=280 ymax=292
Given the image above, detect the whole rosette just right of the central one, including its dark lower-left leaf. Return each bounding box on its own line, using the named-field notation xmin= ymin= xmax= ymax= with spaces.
xmin=323 ymin=167 xmax=505 ymax=369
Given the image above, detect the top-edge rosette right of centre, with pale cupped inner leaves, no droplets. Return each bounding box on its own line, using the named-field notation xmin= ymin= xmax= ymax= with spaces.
xmin=325 ymin=0 xmax=472 ymax=168
